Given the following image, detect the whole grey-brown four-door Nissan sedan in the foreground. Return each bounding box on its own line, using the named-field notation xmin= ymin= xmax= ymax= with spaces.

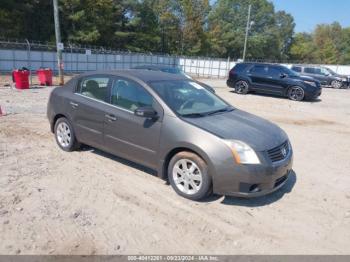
xmin=47 ymin=70 xmax=293 ymax=200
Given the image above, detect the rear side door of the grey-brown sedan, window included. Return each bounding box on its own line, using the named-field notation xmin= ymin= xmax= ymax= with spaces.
xmin=69 ymin=75 xmax=111 ymax=148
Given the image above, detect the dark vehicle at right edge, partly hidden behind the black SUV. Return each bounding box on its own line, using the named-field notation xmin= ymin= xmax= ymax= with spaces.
xmin=291 ymin=65 xmax=350 ymax=89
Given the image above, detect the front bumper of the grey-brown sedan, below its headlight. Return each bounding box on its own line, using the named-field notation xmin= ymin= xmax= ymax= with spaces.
xmin=214 ymin=146 xmax=293 ymax=198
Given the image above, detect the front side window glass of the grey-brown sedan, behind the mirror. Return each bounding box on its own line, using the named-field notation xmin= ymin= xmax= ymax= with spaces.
xmin=110 ymin=79 xmax=153 ymax=111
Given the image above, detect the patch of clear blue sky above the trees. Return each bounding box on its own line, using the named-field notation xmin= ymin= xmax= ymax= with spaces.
xmin=271 ymin=0 xmax=350 ymax=32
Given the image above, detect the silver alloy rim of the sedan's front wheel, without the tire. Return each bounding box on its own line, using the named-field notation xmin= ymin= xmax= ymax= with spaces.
xmin=172 ymin=159 xmax=202 ymax=195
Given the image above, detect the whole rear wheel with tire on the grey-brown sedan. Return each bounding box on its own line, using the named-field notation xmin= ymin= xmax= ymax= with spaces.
xmin=54 ymin=117 xmax=80 ymax=152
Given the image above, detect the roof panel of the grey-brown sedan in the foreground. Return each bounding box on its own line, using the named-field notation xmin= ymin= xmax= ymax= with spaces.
xmin=76 ymin=69 xmax=188 ymax=82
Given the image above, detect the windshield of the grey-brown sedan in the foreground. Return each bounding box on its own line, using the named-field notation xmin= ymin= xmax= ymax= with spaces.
xmin=149 ymin=80 xmax=233 ymax=117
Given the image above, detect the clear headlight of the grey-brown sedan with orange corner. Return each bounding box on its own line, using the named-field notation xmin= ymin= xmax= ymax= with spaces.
xmin=225 ymin=140 xmax=260 ymax=164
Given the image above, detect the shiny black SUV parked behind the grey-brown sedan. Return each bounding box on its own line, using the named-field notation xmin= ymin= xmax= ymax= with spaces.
xmin=227 ymin=63 xmax=322 ymax=101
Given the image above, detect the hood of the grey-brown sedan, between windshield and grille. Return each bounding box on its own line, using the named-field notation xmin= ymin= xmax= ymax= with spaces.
xmin=185 ymin=109 xmax=288 ymax=151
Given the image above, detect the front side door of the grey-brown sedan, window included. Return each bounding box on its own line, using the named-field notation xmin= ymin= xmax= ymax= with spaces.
xmin=104 ymin=77 xmax=163 ymax=168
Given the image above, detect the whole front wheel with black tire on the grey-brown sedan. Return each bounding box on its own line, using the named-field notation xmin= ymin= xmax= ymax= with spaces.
xmin=168 ymin=151 xmax=212 ymax=201
